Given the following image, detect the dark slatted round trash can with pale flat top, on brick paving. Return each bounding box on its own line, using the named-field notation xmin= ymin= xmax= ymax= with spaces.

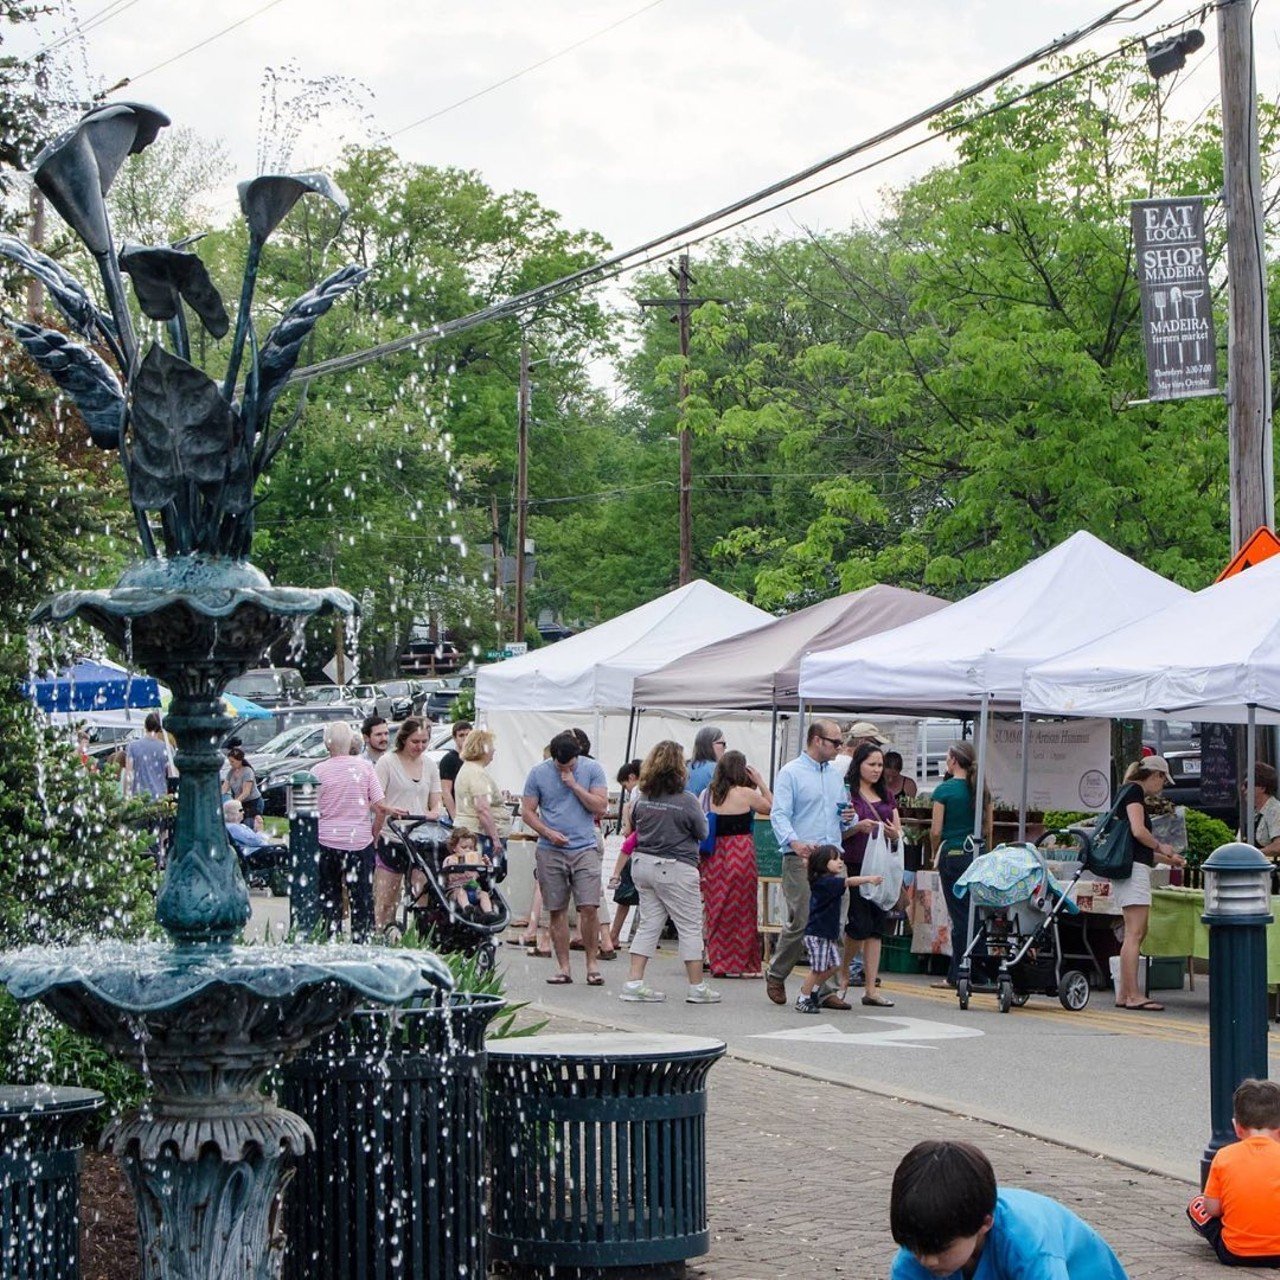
xmin=488 ymin=1032 xmax=724 ymax=1276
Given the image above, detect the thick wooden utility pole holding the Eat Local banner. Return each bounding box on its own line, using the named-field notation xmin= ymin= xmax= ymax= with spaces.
xmin=1217 ymin=0 xmax=1275 ymax=545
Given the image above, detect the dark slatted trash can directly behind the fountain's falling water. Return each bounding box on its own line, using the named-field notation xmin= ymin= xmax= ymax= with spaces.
xmin=280 ymin=993 xmax=504 ymax=1280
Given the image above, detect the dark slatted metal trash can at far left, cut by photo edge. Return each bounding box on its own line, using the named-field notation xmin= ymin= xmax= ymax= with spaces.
xmin=0 ymin=1084 xmax=104 ymax=1280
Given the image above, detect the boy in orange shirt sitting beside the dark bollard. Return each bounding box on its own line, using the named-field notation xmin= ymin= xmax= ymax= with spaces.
xmin=1187 ymin=1080 xmax=1280 ymax=1267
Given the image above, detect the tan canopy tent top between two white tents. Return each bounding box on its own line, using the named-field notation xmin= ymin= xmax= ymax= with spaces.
xmin=631 ymin=586 xmax=948 ymax=710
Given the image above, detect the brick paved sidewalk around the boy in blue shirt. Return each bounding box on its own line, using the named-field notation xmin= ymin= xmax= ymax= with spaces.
xmin=527 ymin=1018 xmax=1221 ymax=1280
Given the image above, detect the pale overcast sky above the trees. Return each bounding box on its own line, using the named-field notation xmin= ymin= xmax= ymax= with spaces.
xmin=9 ymin=0 xmax=1280 ymax=257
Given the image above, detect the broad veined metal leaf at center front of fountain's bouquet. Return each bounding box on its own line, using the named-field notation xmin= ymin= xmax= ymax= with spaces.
xmin=131 ymin=344 xmax=236 ymax=509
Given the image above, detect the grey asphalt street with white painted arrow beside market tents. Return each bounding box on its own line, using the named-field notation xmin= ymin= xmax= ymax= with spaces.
xmin=250 ymin=893 xmax=1280 ymax=1180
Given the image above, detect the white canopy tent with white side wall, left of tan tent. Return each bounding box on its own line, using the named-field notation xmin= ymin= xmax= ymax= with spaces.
xmin=476 ymin=579 xmax=772 ymax=790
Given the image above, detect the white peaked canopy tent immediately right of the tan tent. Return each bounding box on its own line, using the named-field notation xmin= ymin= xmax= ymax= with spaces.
xmin=800 ymin=532 xmax=1190 ymax=835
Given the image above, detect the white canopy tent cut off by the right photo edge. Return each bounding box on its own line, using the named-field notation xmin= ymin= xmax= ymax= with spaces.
xmin=1023 ymin=557 xmax=1280 ymax=819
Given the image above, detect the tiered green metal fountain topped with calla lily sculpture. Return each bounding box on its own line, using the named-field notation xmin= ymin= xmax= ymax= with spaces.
xmin=0 ymin=102 xmax=451 ymax=1280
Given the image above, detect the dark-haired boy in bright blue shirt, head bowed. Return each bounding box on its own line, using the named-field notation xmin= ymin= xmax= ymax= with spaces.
xmin=888 ymin=1142 xmax=1126 ymax=1280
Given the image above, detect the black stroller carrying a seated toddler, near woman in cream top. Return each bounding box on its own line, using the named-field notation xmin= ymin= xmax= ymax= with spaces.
xmin=380 ymin=817 xmax=511 ymax=973
